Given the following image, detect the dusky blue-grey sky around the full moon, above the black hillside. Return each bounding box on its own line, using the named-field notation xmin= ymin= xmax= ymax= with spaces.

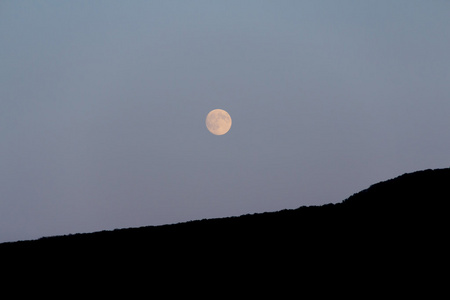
xmin=0 ymin=0 xmax=450 ymax=242
